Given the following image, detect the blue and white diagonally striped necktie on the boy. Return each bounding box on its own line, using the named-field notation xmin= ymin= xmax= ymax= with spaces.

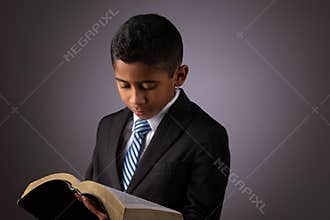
xmin=122 ymin=119 xmax=151 ymax=191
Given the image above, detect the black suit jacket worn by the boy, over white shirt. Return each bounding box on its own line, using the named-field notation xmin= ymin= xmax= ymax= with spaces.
xmin=86 ymin=89 xmax=230 ymax=220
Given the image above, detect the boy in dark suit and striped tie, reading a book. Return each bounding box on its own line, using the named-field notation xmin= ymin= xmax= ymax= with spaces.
xmin=83 ymin=14 xmax=230 ymax=220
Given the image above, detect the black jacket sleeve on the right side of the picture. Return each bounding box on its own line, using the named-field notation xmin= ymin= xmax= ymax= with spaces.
xmin=182 ymin=128 xmax=230 ymax=220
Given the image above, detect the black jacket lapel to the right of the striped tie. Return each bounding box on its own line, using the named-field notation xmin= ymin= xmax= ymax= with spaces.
xmin=127 ymin=89 xmax=191 ymax=193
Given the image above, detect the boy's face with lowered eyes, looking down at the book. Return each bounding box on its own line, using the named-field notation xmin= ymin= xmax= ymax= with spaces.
xmin=114 ymin=60 xmax=185 ymax=119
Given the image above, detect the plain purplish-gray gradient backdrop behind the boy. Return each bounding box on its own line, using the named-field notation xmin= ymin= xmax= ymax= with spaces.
xmin=0 ymin=0 xmax=330 ymax=220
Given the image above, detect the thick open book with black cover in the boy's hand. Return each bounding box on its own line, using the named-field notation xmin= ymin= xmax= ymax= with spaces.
xmin=17 ymin=173 xmax=183 ymax=220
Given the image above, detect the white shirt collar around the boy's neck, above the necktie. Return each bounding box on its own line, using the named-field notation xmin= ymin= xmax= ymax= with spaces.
xmin=132 ymin=88 xmax=180 ymax=132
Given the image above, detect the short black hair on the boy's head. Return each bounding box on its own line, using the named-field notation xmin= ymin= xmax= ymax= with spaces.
xmin=111 ymin=14 xmax=183 ymax=76
